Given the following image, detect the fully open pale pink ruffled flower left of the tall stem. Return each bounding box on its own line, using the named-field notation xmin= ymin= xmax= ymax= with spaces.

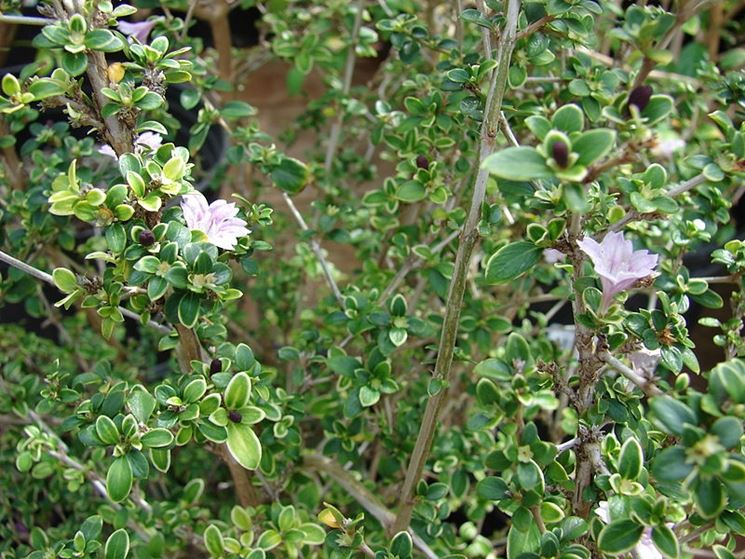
xmin=181 ymin=192 xmax=251 ymax=250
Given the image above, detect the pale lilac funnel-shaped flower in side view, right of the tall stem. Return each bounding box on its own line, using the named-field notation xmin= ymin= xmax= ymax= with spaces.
xmin=577 ymin=231 xmax=658 ymax=310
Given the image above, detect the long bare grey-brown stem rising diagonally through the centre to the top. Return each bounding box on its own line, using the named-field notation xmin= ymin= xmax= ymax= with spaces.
xmin=392 ymin=0 xmax=520 ymax=532
